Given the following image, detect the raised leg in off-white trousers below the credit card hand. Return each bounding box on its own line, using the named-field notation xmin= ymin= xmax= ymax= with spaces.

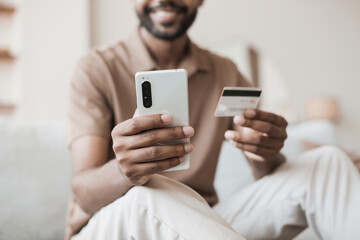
xmin=214 ymin=146 xmax=360 ymax=240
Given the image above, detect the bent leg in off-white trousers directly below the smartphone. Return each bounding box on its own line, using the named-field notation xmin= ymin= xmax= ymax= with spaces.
xmin=72 ymin=175 xmax=244 ymax=240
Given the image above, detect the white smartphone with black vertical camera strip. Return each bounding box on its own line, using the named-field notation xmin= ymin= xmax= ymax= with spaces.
xmin=135 ymin=69 xmax=190 ymax=171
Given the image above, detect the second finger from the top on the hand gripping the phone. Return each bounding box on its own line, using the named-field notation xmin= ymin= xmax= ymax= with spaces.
xmin=126 ymin=126 xmax=194 ymax=149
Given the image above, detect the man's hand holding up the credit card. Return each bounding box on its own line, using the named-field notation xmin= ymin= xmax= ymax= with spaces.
xmin=225 ymin=109 xmax=287 ymax=176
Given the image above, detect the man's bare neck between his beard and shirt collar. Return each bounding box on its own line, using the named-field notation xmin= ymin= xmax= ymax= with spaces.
xmin=140 ymin=27 xmax=189 ymax=69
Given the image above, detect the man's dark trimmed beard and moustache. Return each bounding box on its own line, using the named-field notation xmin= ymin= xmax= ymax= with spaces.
xmin=136 ymin=2 xmax=197 ymax=41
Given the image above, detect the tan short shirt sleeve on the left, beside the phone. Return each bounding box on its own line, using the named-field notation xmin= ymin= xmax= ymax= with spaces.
xmin=68 ymin=52 xmax=112 ymax=145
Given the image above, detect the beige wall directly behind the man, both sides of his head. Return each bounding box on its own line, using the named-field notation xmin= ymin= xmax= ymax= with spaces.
xmin=92 ymin=0 xmax=360 ymax=149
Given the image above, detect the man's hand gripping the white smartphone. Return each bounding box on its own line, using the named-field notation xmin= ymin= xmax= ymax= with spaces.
xmin=111 ymin=114 xmax=194 ymax=185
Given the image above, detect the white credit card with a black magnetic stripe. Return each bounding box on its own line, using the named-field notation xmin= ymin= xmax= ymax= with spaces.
xmin=215 ymin=87 xmax=261 ymax=117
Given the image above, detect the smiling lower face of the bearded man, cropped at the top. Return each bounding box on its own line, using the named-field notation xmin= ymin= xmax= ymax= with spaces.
xmin=133 ymin=0 xmax=203 ymax=41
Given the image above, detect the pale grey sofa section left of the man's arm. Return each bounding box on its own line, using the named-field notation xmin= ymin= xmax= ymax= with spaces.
xmin=0 ymin=119 xmax=70 ymax=240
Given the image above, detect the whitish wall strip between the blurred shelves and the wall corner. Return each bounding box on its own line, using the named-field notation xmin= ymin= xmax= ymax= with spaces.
xmin=19 ymin=0 xmax=89 ymax=121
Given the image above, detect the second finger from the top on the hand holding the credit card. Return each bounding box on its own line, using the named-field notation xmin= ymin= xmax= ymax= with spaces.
xmin=234 ymin=116 xmax=287 ymax=139
